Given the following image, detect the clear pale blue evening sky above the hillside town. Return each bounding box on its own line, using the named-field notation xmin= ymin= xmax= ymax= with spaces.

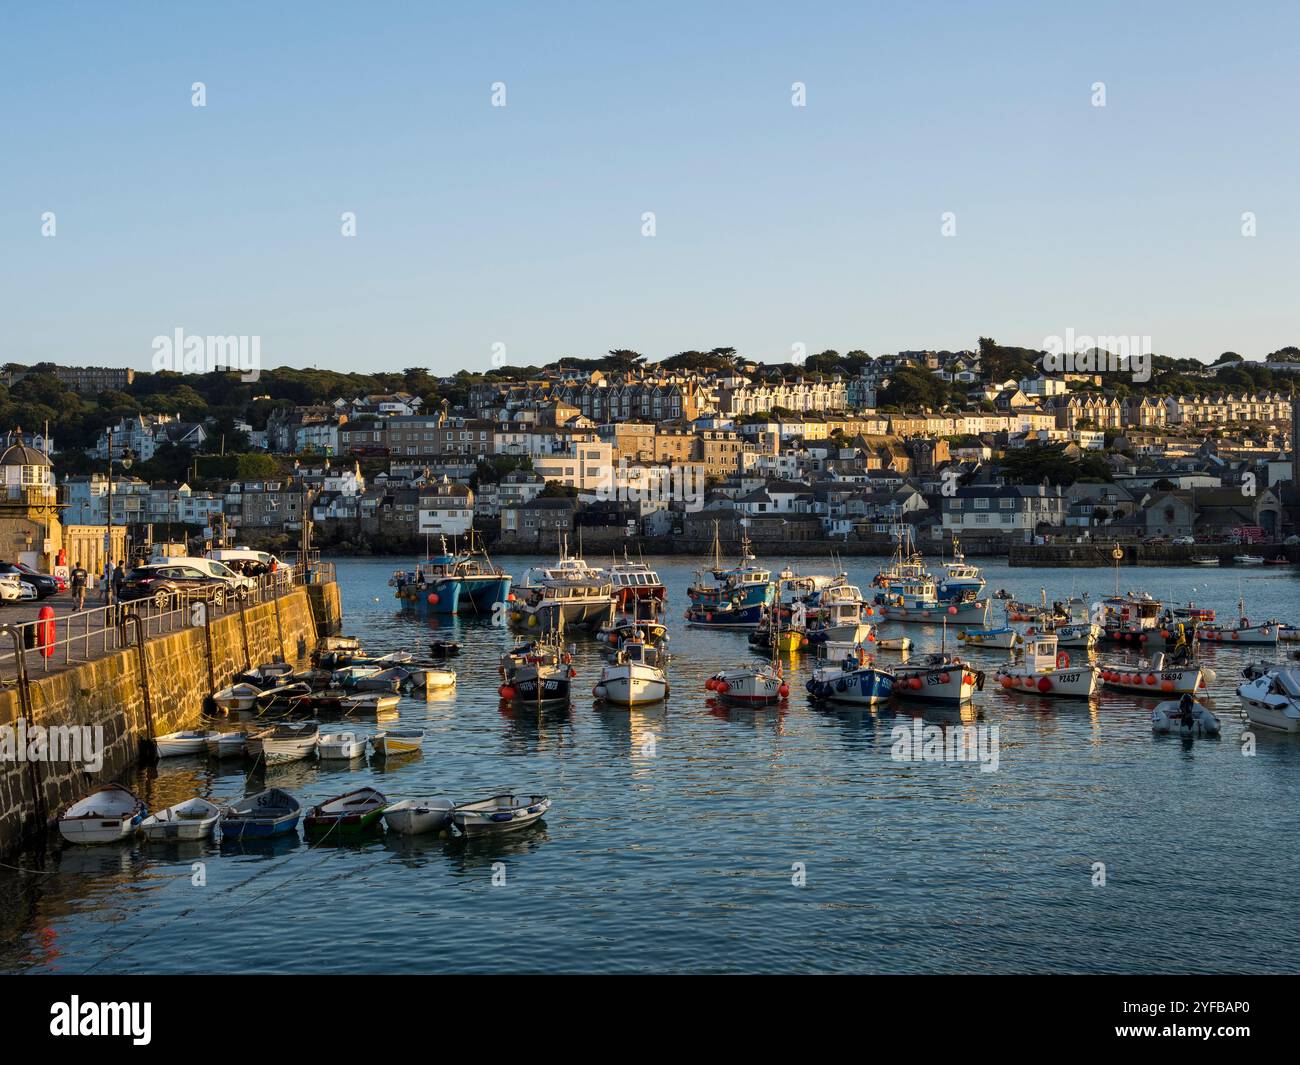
xmin=0 ymin=0 xmax=1300 ymax=372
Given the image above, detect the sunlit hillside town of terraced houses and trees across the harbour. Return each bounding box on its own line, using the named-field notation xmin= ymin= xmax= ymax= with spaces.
xmin=0 ymin=341 xmax=1300 ymax=570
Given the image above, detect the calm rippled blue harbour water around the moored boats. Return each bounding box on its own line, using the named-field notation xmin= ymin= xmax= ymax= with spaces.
xmin=0 ymin=559 xmax=1300 ymax=973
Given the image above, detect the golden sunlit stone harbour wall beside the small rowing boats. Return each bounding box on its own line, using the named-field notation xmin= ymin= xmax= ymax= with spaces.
xmin=0 ymin=584 xmax=341 ymax=854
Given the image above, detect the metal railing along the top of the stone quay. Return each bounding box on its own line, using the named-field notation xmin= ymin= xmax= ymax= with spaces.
xmin=0 ymin=563 xmax=322 ymax=685
